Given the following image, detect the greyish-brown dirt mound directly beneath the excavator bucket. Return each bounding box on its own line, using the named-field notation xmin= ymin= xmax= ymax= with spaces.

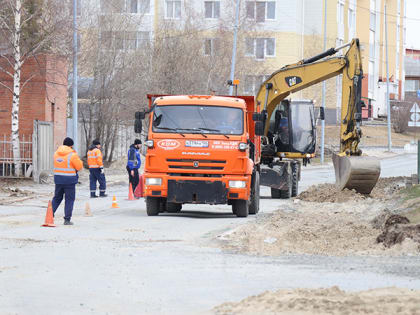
xmin=297 ymin=176 xmax=408 ymax=203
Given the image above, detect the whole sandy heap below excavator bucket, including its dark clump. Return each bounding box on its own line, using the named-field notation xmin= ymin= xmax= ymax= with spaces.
xmin=217 ymin=177 xmax=420 ymax=256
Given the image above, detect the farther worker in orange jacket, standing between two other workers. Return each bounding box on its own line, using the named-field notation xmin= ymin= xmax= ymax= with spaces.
xmin=87 ymin=140 xmax=108 ymax=198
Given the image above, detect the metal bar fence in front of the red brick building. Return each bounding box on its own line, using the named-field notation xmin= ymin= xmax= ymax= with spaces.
xmin=0 ymin=135 xmax=33 ymax=178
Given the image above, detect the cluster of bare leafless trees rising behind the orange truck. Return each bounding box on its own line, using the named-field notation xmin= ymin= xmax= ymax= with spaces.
xmin=80 ymin=0 xmax=264 ymax=161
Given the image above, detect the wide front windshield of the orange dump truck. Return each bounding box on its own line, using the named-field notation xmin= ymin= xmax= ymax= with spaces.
xmin=153 ymin=105 xmax=244 ymax=135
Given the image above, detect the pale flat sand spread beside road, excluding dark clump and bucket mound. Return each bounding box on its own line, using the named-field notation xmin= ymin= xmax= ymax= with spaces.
xmin=218 ymin=200 xmax=420 ymax=256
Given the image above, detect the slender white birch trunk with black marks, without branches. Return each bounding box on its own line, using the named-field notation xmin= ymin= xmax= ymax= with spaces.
xmin=12 ymin=0 xmax=22 ymax=176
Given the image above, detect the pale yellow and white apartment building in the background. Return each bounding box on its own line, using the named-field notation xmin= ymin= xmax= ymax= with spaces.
xmin=77 ymin=0 xmax=406 ymax=123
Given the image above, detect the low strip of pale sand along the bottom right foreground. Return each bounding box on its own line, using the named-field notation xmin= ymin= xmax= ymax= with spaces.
xmin=213 ymin=287 xmax=420 ymax=315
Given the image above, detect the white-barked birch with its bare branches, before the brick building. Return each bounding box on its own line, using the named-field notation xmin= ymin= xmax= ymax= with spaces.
xmin=0 ymin=0 xmax=69 ymax=176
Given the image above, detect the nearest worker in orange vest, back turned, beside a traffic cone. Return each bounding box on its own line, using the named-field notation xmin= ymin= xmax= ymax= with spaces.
xmin=52 ymin=138 xmax=83 ymax=225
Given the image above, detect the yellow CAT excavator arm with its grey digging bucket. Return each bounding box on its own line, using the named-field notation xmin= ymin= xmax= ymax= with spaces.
xmin=256 ymin=39 xmax=380 ymax=193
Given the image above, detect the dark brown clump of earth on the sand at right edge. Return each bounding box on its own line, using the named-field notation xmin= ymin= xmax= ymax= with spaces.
xmin=376 ymin=214 xmax=420 ymax=249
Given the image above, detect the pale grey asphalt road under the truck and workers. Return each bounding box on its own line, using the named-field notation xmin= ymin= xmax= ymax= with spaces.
xmin=0 ymin=155 xmax=420 ymax=314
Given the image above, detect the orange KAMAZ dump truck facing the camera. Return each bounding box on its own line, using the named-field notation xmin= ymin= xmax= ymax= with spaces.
xmin=135 ymin=95 xmax=264 ymax=217
